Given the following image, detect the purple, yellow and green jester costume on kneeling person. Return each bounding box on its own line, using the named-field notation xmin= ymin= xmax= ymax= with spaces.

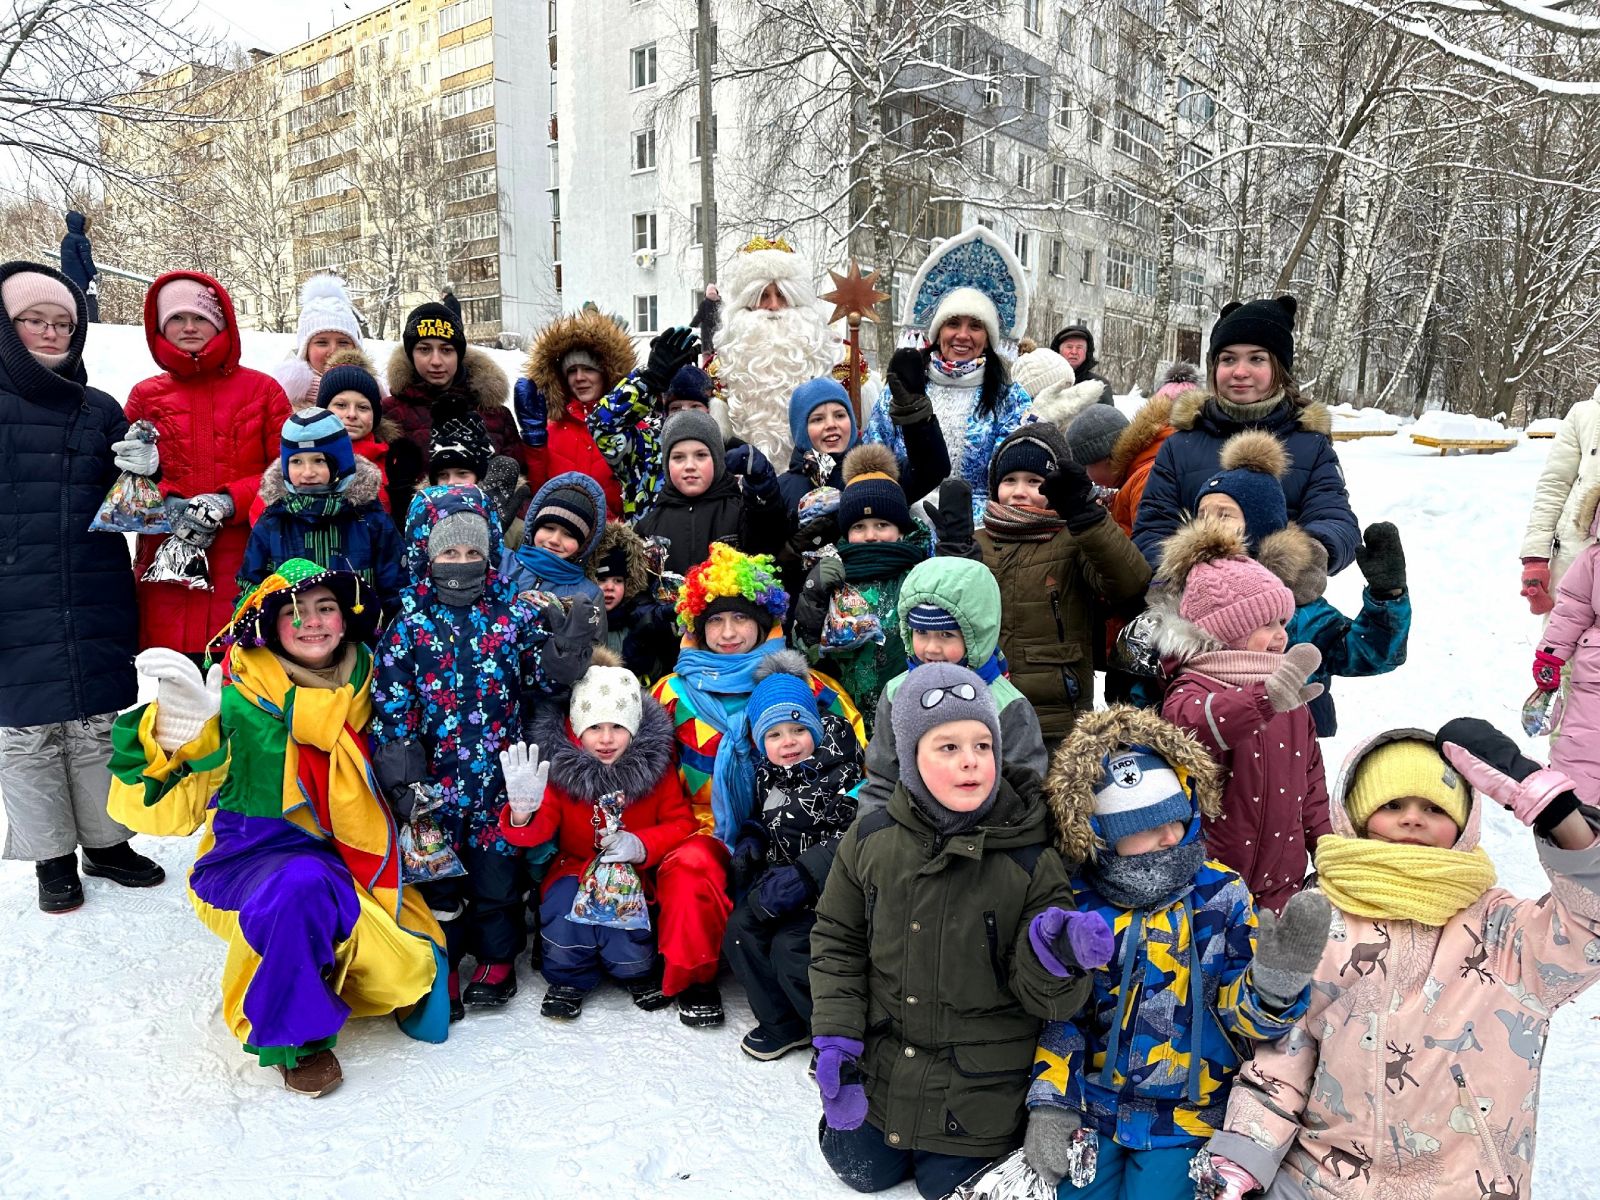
xmin=109 ymin=558 xmax=448 ymax=1067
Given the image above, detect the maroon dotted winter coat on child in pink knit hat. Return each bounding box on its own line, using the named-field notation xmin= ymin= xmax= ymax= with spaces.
xmin=1162 ymin=670 xmax=1333 ymax=912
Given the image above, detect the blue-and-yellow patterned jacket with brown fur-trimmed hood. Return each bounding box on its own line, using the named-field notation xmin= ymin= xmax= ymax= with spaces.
xmin=1027 ymin=707 xmax=1307 ymax=1150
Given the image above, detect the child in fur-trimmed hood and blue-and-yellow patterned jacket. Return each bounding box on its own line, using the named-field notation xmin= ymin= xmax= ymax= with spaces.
xmin=1024 ymin=707 xmax=1330 ymax=1200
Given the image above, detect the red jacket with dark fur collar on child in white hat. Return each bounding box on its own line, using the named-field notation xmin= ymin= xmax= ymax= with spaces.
xmin=501 ymin=696 xmax=694 ymax=894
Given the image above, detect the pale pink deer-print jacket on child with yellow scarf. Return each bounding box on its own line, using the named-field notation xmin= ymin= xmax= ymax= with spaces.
xmin=1208 ymin=730 xmax=1600 ymax=1200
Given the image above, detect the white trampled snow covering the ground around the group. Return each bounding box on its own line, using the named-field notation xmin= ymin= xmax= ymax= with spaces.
xmin=0 ymin=326 xmax=1600 ymax=1200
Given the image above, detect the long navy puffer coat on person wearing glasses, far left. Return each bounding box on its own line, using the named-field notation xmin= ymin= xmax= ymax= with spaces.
xmin=0 ymin=262 xmax=139 ymax=726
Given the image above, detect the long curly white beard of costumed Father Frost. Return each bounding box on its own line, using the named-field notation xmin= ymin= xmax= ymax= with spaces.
xmin=717 ymin=306 xmax=840 ymax=472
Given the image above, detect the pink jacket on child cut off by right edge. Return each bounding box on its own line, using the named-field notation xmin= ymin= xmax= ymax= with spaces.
xmin=1539 ymin=488 xmax=1600 ymax=805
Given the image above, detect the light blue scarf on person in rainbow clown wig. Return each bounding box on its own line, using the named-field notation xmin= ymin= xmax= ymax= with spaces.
xmin=677 ymin=637 xmax=787 ymax=848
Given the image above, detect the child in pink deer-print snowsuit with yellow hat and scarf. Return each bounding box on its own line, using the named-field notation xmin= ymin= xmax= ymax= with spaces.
xmin=1197 ymin=718 xmax=1600 ymax=1200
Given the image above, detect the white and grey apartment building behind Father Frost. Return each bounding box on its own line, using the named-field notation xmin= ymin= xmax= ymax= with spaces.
xmin=546 ymin=0 xmax=1226 ymax=382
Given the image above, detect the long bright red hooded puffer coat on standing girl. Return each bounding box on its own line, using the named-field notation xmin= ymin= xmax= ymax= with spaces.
xmin=125 ymin=270 xmax=290 ymax=654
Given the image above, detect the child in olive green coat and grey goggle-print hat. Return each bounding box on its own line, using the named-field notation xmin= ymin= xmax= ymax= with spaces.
xmin=811 ymin=662 xmax=1110 ymax=1198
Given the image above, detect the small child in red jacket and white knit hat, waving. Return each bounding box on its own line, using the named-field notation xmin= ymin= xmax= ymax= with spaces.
xmin=501 ymin=648 xmax=694 ymax=1021
